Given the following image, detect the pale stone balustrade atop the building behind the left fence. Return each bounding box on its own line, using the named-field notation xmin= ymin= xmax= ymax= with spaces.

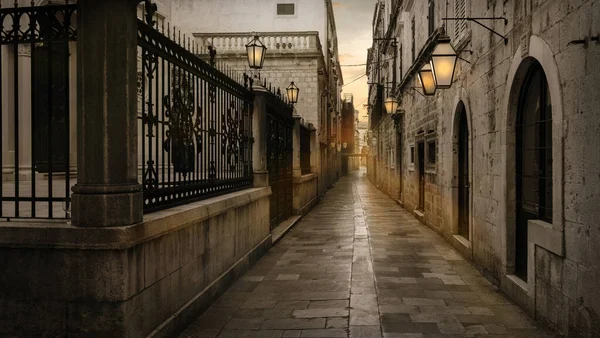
xmin=194 ymin=31 xmax=321 ymax=54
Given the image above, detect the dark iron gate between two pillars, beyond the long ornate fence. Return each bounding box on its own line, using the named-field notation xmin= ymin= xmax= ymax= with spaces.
xmin=267 ymin=91 xmax=294 ymax=227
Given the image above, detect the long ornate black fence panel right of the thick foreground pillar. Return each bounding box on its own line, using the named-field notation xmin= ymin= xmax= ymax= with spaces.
xmin=138 ymin=15 xmax=254 ymax=211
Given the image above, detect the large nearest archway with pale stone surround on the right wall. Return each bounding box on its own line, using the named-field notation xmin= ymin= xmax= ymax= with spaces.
xmin=499 ymin=35 xmax=564 ymax=296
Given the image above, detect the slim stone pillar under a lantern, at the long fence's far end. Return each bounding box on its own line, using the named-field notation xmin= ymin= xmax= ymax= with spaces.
xmin=252 ymin=85 xmax=269 ymax=187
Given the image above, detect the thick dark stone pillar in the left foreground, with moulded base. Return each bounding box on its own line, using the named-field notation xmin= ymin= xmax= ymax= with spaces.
xmin=72 ymin=0 xmax=143 ymax=227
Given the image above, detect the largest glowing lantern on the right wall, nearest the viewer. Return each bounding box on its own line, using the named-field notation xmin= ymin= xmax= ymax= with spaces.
xmin=429 ymin=35 xmax=458 ymax=89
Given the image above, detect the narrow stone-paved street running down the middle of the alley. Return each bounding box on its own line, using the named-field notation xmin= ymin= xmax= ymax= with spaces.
xmin=181 ymin=169 xmax=550 ymax=338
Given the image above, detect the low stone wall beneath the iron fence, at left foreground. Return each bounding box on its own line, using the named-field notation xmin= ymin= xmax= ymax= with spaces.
xmin=0 ymin=188 xmax=271 ymax=337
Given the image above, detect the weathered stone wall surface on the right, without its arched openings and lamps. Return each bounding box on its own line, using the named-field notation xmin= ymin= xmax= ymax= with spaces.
xmin=369 ymin=0 xmax=600 ymax=337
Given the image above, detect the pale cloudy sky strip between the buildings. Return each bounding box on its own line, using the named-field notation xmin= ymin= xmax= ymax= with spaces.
xmin=333 ymin=0 xmax=377 ymax=121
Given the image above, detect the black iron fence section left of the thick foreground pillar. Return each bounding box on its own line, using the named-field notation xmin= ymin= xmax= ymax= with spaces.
xmin=0 ymin=4 xmax=77 ymax=219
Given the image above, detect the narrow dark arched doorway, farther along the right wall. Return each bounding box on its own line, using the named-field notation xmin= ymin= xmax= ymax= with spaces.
xmin=458 ymin=105 xmax=471 ymax=240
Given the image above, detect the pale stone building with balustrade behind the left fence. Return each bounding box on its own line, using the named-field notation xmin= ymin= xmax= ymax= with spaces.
xmin=172 ymin=0 xmax=343 ymax=195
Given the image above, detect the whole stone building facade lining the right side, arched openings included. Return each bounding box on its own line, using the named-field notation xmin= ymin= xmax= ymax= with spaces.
xmin=368 ymin=0 xmax=600 ymax=337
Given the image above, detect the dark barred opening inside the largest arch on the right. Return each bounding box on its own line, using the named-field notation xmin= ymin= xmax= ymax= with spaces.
xmin=515 ymin=62 xmax=552 ymax=278
